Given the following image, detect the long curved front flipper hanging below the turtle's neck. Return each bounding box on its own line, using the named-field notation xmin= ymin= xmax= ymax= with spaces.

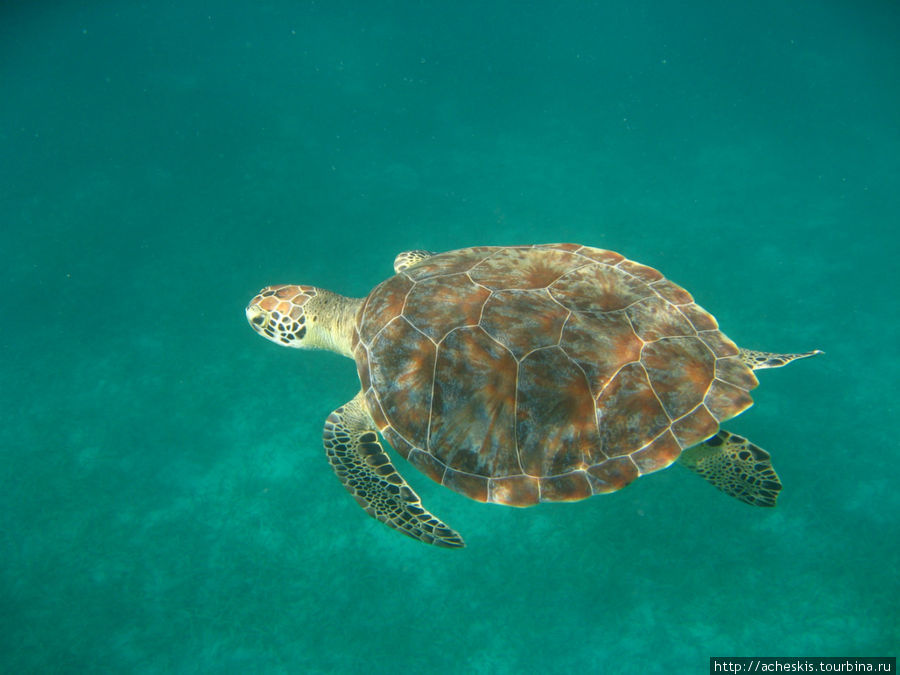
xmin=323 ymin=392 xmax=465 ymax=548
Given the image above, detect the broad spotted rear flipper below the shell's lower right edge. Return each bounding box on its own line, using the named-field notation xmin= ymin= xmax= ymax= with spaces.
xmin=678 ymin=430 xmax=781 ymax=506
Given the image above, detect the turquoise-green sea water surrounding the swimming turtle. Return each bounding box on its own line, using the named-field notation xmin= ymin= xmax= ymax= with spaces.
xmin=0 ymin=0 xmax=900 ymax=673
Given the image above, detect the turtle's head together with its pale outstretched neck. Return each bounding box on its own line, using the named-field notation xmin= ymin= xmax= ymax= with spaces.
xmin=246 ymin=284 xmax=362 ymax=358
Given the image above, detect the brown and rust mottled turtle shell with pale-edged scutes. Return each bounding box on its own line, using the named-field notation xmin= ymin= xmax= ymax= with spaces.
xmin=352 ymin=244 xmax=757 ymax=506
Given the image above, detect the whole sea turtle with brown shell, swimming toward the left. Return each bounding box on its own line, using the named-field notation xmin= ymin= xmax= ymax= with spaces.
xmin=246 ymin=244 xmax=821 ymax=547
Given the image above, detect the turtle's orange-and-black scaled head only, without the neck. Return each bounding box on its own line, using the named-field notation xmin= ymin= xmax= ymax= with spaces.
xmin=247 ymin=284 xmax=318 ymax=349
